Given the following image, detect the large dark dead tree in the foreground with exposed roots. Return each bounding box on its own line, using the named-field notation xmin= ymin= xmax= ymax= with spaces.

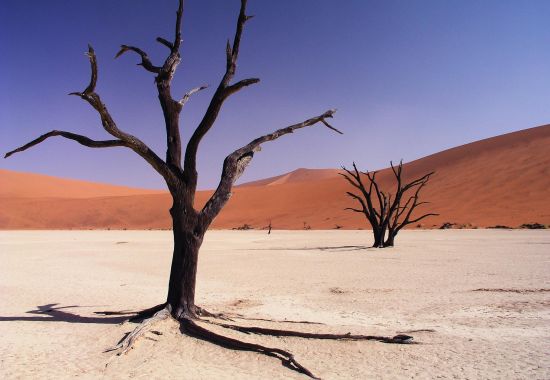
xmin=5 ymin=0 xmax=414 ymax=377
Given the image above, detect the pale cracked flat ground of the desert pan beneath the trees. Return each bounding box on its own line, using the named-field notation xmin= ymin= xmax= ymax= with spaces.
xmin=0 ymin=230 xmax=550 ymax=379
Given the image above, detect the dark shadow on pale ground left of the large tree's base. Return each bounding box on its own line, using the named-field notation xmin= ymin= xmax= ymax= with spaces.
xmin=0 ymin=303 xmax=132 ymax=324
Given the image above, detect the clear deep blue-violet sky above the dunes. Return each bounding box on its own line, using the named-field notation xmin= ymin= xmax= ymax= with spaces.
xmin=0 ymin=0 xmax=550 ymax=188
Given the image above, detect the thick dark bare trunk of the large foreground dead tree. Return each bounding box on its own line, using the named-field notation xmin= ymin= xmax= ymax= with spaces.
xmin=166 ymin=196 xmax=205 ymax=319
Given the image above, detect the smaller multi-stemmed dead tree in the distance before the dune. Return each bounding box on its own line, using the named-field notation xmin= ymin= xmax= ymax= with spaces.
xmin=339 ymin=161 xmax=439 ymax=248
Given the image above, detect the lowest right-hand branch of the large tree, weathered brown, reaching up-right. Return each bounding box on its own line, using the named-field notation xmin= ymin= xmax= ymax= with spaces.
xmin=201 ymin=110 xmax=336 ymax=224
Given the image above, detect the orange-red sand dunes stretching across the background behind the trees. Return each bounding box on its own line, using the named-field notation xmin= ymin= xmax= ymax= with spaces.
xmin=0 ymin=125 xmax=550 ymax=229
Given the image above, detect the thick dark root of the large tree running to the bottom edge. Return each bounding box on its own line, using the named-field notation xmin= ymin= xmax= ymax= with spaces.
xmin=180 ymin=318 xmax=320 ymax=379
